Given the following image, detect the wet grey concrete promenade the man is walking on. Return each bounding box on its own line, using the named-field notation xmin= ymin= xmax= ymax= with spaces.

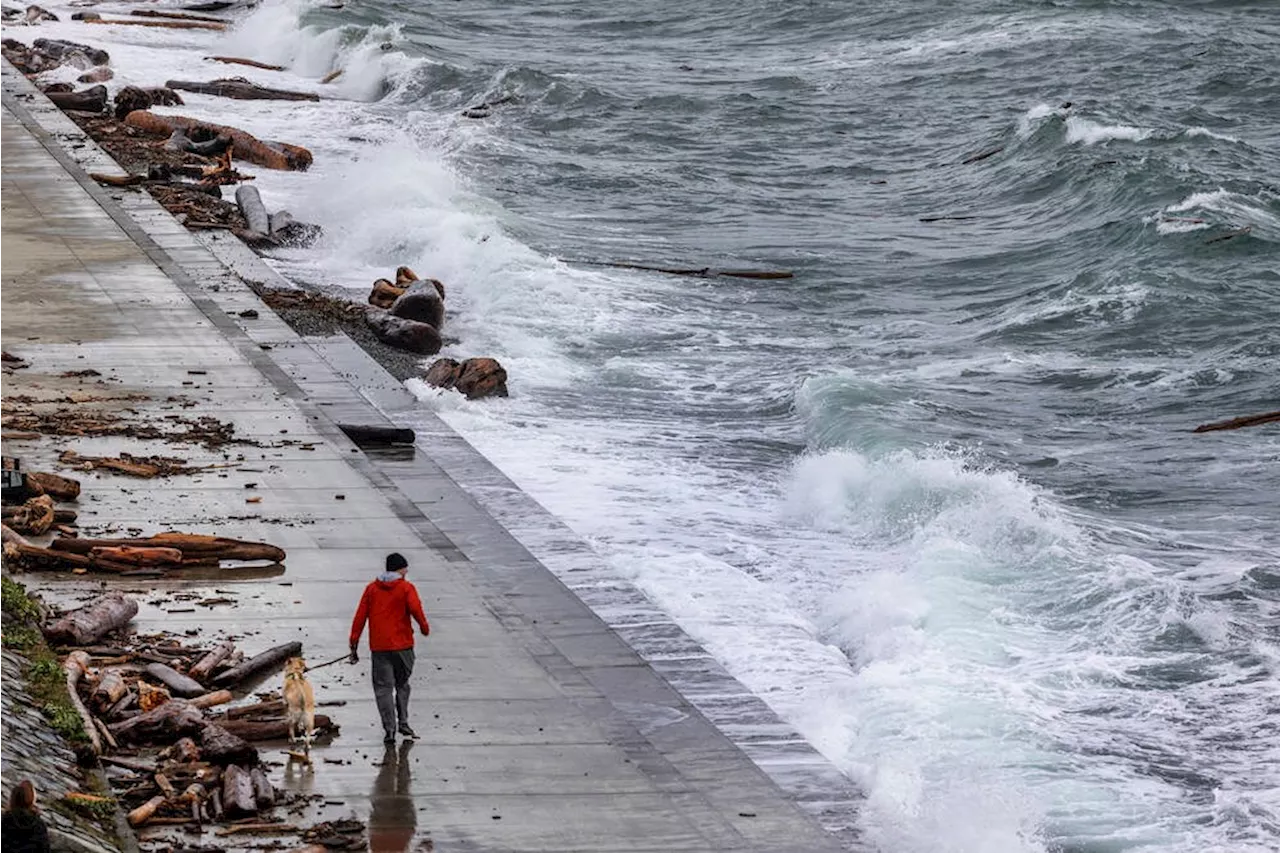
xmin=0 ymin=66 xmax=860 ymax=853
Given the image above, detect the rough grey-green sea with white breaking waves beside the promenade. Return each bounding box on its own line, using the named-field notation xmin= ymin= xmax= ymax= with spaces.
xmin=6 ymin=0 xmax=1280 ymax=853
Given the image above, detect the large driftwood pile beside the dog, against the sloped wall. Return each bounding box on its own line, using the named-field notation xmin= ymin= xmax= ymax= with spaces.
xmin=44 ymin=593 xmax=337 ymax=831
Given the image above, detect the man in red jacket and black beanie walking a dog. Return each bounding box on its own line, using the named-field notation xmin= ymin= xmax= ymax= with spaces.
xmin=351 ymin=553 xmax=431 ymax=743
